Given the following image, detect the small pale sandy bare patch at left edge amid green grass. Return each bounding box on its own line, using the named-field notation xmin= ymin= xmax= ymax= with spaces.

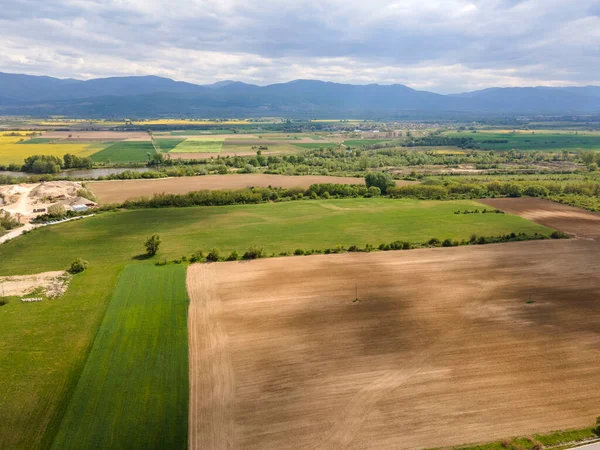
xmin=0 ymin=271 xmax=71 ymax=298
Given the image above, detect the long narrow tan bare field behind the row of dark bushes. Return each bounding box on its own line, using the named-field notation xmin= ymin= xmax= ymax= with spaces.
xmin=87 ymin=174 xmax=411 ymax=203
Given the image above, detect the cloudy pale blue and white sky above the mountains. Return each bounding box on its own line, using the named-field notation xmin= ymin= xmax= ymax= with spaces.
xmin=0 ymin=0 xmax=600 ymax=94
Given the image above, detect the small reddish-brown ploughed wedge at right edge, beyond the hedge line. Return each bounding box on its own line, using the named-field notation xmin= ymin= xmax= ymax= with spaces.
xmin=478 ymin=197 xmax=600 ymax=240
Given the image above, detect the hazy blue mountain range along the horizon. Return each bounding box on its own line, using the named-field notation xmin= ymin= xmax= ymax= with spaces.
xmin=0 ymin=72 xmax=600 ymax=118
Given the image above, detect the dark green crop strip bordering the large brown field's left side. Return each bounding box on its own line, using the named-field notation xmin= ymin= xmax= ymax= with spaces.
xmin=52 ymin=264 xmax=189 ymax=450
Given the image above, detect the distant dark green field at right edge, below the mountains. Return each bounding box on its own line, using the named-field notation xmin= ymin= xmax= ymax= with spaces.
xmin=447 ymin=131 xmax=600 ymax=150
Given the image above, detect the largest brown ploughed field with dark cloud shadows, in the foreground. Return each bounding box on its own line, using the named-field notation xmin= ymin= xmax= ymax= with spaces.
xmin=187 ymin=239 xmax=600 ymax=450
